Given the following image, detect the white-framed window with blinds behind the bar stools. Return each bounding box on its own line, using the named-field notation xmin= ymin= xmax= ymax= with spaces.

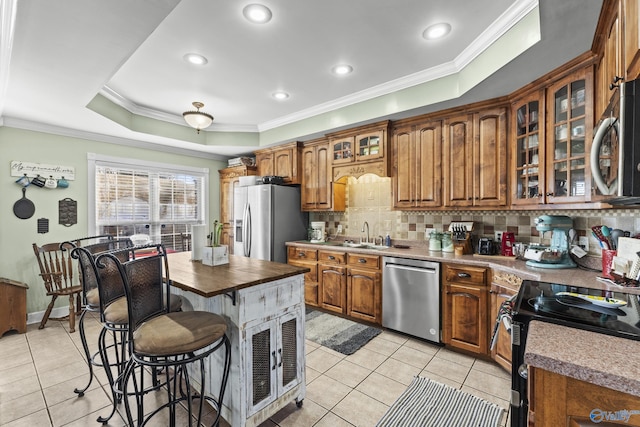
xmin=94 ymin=156 xmax=207 ymax=251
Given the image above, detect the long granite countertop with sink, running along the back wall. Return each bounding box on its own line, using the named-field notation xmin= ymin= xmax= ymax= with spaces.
xmin=287 ymin=241 xmax=640 ymax=294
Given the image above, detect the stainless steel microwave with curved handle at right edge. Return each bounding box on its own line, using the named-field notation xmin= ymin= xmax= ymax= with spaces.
xmin=590 ymin=79 xmax=640 ymax=205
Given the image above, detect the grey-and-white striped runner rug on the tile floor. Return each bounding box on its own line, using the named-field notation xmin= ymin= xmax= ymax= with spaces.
xmin=376 ymin=377 xmax=503 ymax=427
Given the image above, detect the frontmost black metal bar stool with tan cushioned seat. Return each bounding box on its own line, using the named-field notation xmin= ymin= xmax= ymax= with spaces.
xmin=96 ymin=245 xmax=231 ymax=426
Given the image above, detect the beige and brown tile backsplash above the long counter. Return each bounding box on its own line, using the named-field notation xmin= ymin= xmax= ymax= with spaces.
xmin=309 ymin=175 xmax=640 ymax=256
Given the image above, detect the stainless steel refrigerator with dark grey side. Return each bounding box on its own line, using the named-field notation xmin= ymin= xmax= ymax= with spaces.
xmin=233 ymin=184 xmax=308 ymax=263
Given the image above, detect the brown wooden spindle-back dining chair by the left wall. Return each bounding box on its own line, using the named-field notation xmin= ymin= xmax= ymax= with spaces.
xmin=33 ymin=243 xmax=82 ymax=332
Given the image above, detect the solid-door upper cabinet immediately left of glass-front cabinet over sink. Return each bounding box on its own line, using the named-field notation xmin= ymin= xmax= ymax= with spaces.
xmin=301 ymin=138 xmax=346 ymax=211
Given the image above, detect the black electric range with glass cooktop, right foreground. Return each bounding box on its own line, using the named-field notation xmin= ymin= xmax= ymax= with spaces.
xmin=511 ymin=280 xmax=640 ymax=427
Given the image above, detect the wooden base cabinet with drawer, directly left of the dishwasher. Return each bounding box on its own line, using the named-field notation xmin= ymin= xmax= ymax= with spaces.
xmin=346 ymin=253 xmax=382 ymax=325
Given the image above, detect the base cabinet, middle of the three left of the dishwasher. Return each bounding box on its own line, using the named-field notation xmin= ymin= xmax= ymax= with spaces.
xmin=318 ymin=251 xmax=347 ymax=314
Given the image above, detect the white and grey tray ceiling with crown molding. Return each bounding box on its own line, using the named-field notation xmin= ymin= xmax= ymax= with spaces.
xmin=0 ymin=0 xmax=602 ymax=158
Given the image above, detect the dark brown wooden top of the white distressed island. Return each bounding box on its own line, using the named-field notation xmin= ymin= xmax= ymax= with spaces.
xmin=167 ymin=252 xmax=309 ymax=298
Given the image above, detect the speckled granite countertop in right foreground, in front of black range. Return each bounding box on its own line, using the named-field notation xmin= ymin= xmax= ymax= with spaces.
xmin=524 ymin=320 xmax=640 ymax=397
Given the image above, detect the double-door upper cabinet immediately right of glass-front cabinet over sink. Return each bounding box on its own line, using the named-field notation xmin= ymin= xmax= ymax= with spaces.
xmin=391 ymin=120 xmax=442 ymax=209
